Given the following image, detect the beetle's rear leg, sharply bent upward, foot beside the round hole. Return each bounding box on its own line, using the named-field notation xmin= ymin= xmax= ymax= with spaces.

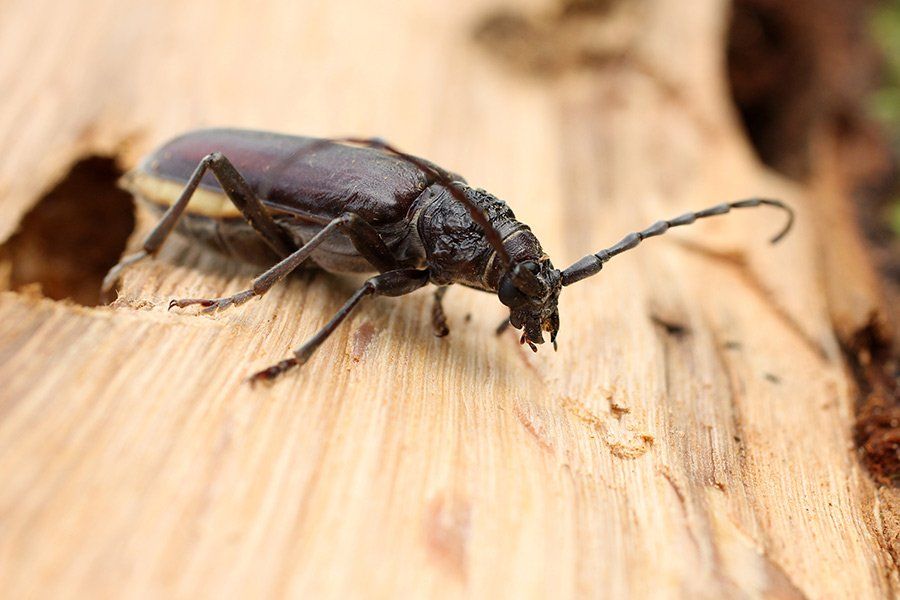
xmin=101 ymin=152 xmax=296 ymax=296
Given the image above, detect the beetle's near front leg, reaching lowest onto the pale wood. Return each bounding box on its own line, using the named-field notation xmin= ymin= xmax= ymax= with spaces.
xmin=249 ymin=269 xmax=429 ymax=383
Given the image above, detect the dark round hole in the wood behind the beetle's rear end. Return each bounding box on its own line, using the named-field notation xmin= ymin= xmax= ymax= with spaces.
xmin=0 ymin=156 xmax=134 ymax=306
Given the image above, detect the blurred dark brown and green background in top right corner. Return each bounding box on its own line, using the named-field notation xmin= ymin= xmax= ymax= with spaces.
xmin=729 ymin=0 xmax=900 ymax=300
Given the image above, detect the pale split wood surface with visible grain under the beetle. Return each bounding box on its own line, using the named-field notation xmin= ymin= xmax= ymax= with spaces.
xmin=0 ymin=0 xmax=900 ymax=598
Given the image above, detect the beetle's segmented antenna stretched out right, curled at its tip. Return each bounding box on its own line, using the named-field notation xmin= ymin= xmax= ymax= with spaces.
xmin=562 ymin=198 xmax=794 ymax=285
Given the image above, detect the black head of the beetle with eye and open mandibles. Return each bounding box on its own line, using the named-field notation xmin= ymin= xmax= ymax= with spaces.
xmin=497 ymin=258 xmax=562 ymax=352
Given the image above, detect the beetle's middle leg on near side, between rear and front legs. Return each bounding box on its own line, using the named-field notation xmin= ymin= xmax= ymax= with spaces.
xmin=169 ymin=213 xmax=398 ymax=312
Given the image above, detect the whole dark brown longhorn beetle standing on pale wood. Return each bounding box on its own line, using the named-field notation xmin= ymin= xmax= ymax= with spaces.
xmin=103 ymin=129 xmax=794 ymax=381
